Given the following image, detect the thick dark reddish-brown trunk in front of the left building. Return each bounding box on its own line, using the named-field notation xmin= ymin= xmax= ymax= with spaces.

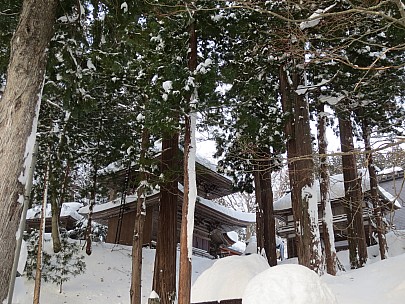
xmin=153 ymin=134 xmax=179 ymax=304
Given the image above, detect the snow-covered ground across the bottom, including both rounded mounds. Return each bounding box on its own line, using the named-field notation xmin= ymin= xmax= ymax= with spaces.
xmin=13 ymin=231 xmax=405 ymax=304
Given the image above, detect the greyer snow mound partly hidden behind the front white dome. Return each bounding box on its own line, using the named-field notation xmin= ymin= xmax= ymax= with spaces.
xmin=191 ymin=254 xmax=269 ymax=303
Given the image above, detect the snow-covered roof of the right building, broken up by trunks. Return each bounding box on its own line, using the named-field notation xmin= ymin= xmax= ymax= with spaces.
xmin=273 ymin=169 xmax=402 ymax=211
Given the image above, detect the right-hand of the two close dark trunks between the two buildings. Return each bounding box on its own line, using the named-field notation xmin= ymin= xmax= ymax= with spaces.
xmin=259 ymin=157 xmax=277 ymax=266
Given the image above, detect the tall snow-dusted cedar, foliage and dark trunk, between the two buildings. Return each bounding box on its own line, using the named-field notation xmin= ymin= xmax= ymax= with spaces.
xmin=211 ymin=5 xmax=284 ymax=265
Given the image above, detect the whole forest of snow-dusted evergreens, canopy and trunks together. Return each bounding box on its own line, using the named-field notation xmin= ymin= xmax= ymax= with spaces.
xmin=0 ymin=0 xmax=405 ymax=303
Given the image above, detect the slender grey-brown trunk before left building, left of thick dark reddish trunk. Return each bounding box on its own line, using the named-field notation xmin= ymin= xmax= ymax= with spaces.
xmin=129 ymin=128 xmax=149 ymax=304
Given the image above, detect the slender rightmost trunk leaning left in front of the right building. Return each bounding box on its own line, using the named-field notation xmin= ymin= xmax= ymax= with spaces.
xmin=362 ymin=119 xmax=388 ymax=260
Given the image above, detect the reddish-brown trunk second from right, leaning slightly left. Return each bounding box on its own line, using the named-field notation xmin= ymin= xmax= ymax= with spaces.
xmin=338 ymin=114 xmax=367 ymax=269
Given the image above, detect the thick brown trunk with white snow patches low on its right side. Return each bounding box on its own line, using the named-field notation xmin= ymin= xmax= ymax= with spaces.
xmin=279 ymin=66 xmax=322 ymax=272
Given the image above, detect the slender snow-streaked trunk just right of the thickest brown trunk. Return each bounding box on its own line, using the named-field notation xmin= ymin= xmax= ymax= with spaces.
xmin=318 ymin=103 xmax=337 ymax=275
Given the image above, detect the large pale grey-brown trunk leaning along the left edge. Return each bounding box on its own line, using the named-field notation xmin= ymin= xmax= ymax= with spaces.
xmin=0 ymin=0 xmax=58 ymax=302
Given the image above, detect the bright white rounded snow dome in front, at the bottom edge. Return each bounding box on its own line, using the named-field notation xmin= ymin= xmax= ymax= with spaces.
xmin=242 ymin=264 xmax=337 ymax=304
